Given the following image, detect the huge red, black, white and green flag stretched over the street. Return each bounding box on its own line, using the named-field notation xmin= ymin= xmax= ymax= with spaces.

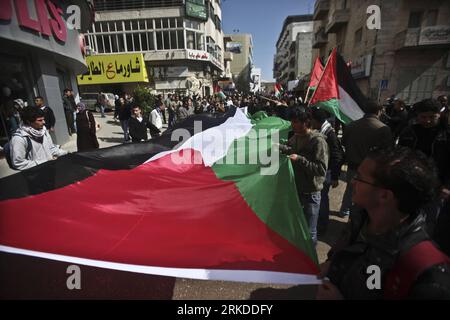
xmin=0 ymin=109 xmax=318 ymax=290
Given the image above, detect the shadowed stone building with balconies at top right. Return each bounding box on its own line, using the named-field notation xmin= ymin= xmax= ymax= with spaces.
xmin=313 ymin=0 xmax=450 ymax=103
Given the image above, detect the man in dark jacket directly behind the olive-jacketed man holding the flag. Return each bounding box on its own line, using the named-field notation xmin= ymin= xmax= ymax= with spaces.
xmin=311 ymin=108 xmax=344 ymax=233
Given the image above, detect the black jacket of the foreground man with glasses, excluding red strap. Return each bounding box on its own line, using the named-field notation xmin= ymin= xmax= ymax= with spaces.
xmin=327 ymin=211 xmax=450 ymax=300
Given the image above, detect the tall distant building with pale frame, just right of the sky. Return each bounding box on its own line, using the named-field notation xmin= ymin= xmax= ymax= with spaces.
xmin=273 ymin=15 xmax=314 ymax=86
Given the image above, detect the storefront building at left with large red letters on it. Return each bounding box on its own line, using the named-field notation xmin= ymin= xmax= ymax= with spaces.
xmin=0 ymin=0 xmax=92 ymax=144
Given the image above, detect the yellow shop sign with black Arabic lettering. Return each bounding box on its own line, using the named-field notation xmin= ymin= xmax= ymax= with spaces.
xmin=77 ymin=53 xmax=148 ymax=85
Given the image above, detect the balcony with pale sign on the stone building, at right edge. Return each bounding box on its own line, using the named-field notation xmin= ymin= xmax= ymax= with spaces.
xmin=394 ymin=25 xmax=450 ymax=51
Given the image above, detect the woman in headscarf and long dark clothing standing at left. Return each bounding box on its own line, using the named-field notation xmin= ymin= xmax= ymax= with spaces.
xmin=77 ymin=102 xmax=99 ymax=152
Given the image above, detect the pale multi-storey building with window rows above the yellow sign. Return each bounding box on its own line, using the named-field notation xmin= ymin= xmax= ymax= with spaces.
xmin=86 ymin=0 xmax=224 ymax=95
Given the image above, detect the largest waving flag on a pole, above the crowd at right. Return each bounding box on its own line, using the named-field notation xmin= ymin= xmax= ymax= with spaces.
xmin=309 ymin=49 xmax=367 ymax=124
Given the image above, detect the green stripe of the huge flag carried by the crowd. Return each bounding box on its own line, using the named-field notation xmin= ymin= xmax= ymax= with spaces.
xmin=212 ymin=116 xmax=318 ymax=264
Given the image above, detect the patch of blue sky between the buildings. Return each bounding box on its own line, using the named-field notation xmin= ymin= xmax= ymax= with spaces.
xmin=222 ymin=0 xmax=315 ymax=81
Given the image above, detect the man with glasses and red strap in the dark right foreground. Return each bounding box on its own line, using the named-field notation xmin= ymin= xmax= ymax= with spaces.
xmin=318 ymin=148 xmax=450 ymax=299
